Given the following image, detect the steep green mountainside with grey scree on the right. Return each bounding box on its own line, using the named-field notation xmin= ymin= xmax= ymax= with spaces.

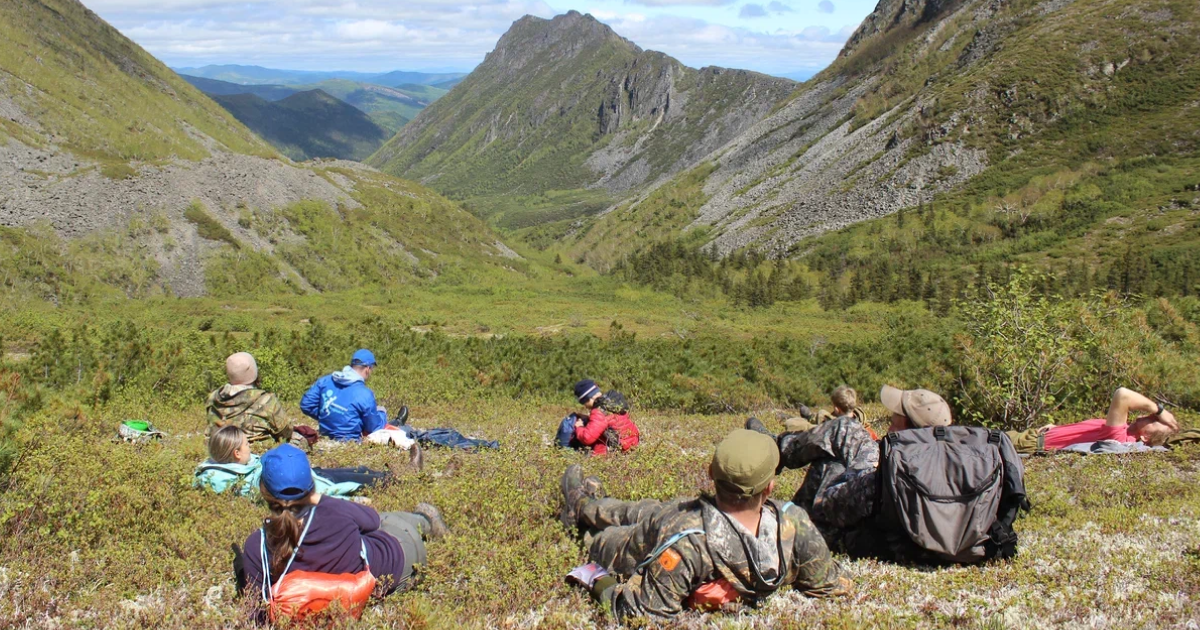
xmin=564 ymin=0 xmax=1200 ymax=304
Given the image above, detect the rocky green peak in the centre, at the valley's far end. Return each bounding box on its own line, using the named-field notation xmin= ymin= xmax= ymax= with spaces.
xmin=370 ymin=12 xmax=794 ymax=220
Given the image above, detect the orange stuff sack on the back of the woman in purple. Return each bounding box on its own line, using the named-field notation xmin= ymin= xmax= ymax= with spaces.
xmin=266 ymin=566 xmax=376 ymax=623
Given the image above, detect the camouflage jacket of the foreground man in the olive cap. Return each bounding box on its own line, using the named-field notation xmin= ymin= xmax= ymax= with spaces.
xmin=600 ymin=497 xmax=850 ymax=618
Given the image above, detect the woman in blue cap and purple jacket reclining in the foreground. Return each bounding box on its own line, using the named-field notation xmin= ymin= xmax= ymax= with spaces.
xmin=234 ymin=444 xmax=448 ymax=610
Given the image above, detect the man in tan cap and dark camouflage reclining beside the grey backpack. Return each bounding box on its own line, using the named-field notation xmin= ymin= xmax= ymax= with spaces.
xmin=763 ymin=385 xmax=952 ymax=556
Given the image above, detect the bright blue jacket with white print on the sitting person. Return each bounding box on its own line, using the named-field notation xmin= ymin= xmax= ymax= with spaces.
xmin=300 ymin=366 xmax=388 ymax=442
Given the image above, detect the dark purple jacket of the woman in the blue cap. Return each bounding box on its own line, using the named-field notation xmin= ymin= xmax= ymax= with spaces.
xmin=245 ymin=496 xmax=404 ymax=593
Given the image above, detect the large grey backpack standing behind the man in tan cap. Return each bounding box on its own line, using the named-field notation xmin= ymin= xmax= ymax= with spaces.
xmin=878 ymin=426 xmax=1028 ymax=564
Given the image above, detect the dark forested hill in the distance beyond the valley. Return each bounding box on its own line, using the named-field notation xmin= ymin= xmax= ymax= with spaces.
xmin=212 ymin=90 xmax=391 ymax=161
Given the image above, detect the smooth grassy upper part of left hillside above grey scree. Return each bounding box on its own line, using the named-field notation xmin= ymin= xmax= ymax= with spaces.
xmin=0 ymin=0 xmax=275 ymax=163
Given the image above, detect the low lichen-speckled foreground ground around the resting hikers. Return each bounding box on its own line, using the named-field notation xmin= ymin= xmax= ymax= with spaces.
xmin=0 ymin=404 xmax=1200 ymax=629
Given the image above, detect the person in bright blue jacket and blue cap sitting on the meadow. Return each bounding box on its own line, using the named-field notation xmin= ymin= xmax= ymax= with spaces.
xmin=300 ymin=349 xmax=415 ymax=450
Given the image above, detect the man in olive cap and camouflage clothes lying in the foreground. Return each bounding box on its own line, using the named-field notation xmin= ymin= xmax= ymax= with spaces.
xmin=560 ymin=430 xmax=852 ymax=618
